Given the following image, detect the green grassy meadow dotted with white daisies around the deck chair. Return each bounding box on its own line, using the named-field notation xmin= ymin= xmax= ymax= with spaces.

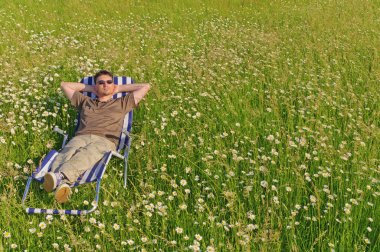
xmin=0 ymin=0 xmax=380 ymax=251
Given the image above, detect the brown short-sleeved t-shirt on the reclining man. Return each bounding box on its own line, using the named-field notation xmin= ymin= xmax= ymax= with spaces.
xmin=71 ymin=91 xmax=136 ymax=146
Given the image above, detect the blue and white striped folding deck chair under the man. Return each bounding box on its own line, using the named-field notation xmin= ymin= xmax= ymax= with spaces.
xmin=22 ymin=76 xmax=134 ymax=215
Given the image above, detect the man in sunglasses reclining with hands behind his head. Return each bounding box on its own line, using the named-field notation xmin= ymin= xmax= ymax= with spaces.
xmin=43 ymin=70 xmax=150 ymax=203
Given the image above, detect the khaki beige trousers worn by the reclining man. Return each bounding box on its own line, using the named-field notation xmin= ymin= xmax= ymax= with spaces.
xmin=51 ymin=135 xmax=116 ymax=183
